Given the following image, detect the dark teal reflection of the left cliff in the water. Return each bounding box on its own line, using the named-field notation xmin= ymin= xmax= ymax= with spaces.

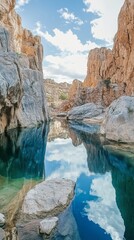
xmin=0 ymin=126 xmax=47 ymax=179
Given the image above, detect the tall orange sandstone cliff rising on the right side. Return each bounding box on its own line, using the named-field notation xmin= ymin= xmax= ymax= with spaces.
xmin=70 ymin=0 xmax=134 ymax=106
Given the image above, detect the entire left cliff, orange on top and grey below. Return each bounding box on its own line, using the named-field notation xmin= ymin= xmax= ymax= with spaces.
xmin=0 ymin=0 xmax=48 ymax=133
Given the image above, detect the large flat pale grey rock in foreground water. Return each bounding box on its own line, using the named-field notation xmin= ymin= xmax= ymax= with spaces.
xmin=22 ymin=179 xmax=75 ymax=218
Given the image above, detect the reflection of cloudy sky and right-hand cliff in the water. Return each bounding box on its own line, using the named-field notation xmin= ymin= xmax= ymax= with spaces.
xmin=46 ymin=123 xmax=134 ymax=240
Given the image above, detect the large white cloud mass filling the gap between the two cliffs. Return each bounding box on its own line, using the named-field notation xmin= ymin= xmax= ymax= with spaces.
xmin=34 ymin=22 xmax=98 ymax=82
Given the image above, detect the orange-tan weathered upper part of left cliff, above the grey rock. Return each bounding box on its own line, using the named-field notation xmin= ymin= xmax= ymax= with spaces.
xmin=0 ymin=0 xmax=43 ymax=70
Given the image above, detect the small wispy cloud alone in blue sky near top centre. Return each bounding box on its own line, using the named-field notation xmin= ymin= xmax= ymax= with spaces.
xmin=58 ymin=8 xmax=84 ymax=25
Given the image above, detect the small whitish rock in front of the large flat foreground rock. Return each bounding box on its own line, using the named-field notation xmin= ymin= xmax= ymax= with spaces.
xmin=39 ymin=217 xmax=58 ymax=235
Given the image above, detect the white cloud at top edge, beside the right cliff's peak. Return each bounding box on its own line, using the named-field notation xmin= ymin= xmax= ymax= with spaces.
xmin=83 ymin=0 xmax=124 ymax=44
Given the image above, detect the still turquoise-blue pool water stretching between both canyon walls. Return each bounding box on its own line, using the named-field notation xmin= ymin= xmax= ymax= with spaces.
xmin=0 ymin=121 xmax=134 ymax=240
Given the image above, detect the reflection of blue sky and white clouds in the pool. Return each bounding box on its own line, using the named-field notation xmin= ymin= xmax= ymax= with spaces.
xmin=45 ymin=138 xmax=124 ymax=240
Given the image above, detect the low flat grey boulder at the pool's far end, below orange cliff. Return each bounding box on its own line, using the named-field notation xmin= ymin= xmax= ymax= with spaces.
xmin=67 ymin=103 xmax=104 ymax=120
